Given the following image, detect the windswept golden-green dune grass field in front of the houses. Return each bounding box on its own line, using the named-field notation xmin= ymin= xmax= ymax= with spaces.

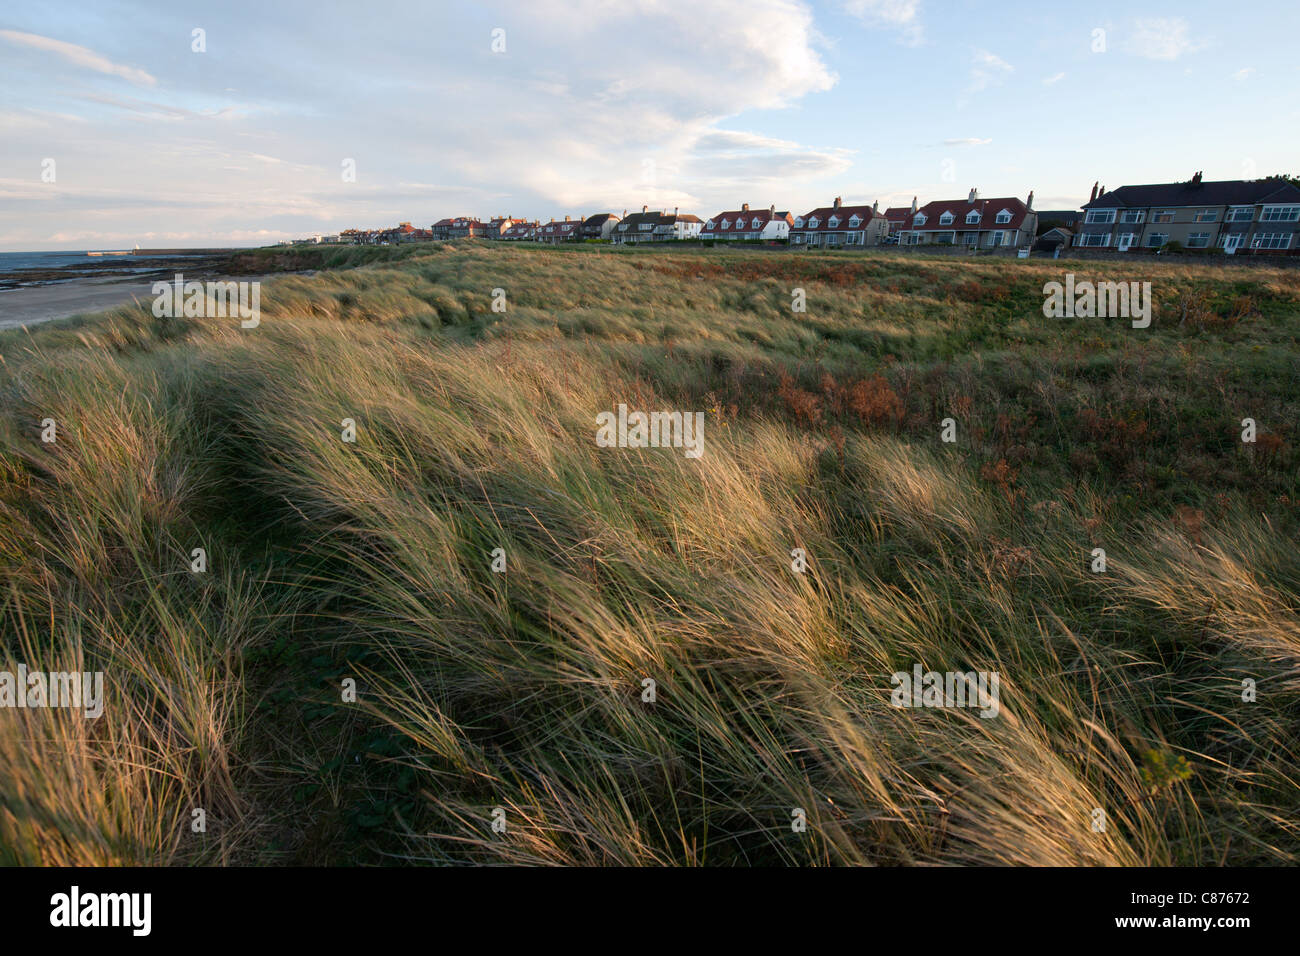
xmin=0 ymin=242 xmax=1300 ymax=865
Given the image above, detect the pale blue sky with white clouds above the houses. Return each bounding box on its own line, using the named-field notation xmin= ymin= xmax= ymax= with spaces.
xmin=0 ymin=0 xmax=1300 ymax=251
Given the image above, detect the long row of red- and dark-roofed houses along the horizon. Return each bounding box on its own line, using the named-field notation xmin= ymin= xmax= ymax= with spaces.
xmin=315 ymin=173 xmax=1300 ymax=255
